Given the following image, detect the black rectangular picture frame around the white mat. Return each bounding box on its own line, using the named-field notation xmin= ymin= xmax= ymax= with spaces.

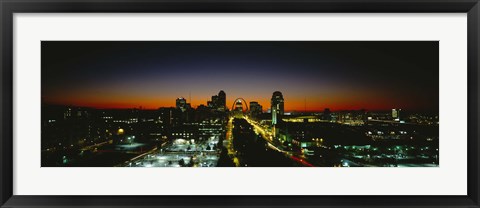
xmin=0 ymin=0 xmax=480 ymax=207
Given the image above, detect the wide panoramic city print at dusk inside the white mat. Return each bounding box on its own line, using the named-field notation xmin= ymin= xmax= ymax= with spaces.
xmin=40 ymin=41 xmax=440 ymax=168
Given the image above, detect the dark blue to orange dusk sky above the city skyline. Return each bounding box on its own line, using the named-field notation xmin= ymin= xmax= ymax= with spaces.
xmin=41 ymin=41 xmax=439 ymax=112
